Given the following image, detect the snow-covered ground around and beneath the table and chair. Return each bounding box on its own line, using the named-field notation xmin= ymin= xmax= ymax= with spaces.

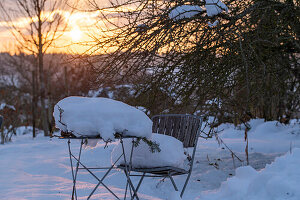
xmin=0 ymin=119 xmax=300 ymax=200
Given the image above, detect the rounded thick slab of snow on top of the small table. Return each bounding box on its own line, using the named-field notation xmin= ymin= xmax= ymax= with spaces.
xmin=53 ymin=97 xmax=152 ymax=141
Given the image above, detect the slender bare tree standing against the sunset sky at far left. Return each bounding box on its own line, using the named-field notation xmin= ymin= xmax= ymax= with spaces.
xmin=0 ymin=0 xmax=73 ymax=136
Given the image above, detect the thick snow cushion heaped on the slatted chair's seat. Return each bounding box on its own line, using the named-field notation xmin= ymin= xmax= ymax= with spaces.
xmin=111 ymin=133 xmax=187 ymax=168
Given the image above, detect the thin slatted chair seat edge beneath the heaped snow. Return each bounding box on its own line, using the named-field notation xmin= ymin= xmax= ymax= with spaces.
xmin=118 ymin=165 xmax=189 ymax=176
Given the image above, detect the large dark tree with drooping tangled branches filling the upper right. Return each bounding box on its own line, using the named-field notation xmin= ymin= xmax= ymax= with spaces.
xmin=88 ymin=0 xmax=300 ymax=123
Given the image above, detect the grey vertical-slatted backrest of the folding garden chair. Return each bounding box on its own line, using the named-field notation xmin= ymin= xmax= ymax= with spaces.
xmin=152 ymin=114 xmax=202 ymax=148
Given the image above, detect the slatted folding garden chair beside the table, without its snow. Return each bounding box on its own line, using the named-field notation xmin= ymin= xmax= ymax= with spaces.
xmin=119 ymin=114 xmax=202 ymax=197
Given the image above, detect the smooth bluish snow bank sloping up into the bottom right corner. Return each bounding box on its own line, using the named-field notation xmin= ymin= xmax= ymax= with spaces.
xmin=201 ymin=148 xmax=300 ymax=200
